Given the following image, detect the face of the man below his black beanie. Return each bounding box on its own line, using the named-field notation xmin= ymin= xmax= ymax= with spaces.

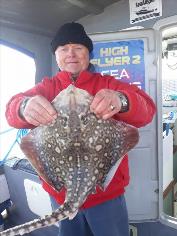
xmin=55 ymin=44 xmax=89 ymax=75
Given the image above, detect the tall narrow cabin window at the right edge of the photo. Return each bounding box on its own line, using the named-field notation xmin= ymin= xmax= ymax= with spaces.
xmin=161 ymin=25 xmax=177 ymax=221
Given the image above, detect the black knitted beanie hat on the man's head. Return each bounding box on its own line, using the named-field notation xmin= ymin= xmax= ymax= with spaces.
xmin=51 ymin=22 xmax=93 ymax=54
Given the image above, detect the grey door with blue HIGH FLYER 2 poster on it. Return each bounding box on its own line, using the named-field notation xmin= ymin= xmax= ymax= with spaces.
xmin=91 ymin=30 xmax=159 ymax=222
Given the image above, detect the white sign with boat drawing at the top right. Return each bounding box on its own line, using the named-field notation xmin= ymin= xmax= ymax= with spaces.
xmin=129 ymin=0 xmax=162 ymax=24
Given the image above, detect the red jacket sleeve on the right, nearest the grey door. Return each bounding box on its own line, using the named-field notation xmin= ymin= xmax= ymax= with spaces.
xmin=109 ymin=79 xmax=156 ymax=128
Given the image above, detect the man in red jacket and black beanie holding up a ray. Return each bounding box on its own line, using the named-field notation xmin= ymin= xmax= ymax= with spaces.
xmin=6 ymin=23 xmax=155 ymax=236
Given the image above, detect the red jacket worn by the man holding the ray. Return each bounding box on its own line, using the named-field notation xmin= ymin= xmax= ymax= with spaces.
xmin=6 ymin=71 xmax=156 ymax=208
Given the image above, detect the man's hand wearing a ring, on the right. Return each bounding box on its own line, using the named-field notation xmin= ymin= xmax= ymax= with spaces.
xmin=90 ymin=89 xmax=121 ymax=120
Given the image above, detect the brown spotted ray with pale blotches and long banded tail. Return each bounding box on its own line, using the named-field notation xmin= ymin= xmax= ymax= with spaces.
xmin=0 ymin=85 xmax=139 ymax=236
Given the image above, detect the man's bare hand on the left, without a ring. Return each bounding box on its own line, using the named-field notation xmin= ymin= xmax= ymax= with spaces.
xmin=20 ymin=95 xmax=57 ymax=126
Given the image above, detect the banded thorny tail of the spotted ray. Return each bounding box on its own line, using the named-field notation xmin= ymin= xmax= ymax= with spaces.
xmin=0 ymin=203 xmax=77 ymax=236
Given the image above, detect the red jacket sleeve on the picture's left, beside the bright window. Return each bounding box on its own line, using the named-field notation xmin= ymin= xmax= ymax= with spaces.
xmin=5 ymin=78 xmax=54 ymax=129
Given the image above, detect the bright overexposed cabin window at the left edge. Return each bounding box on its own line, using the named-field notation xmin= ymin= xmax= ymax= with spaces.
xmin=0 ymin=42 xmax=36 ymax=164
